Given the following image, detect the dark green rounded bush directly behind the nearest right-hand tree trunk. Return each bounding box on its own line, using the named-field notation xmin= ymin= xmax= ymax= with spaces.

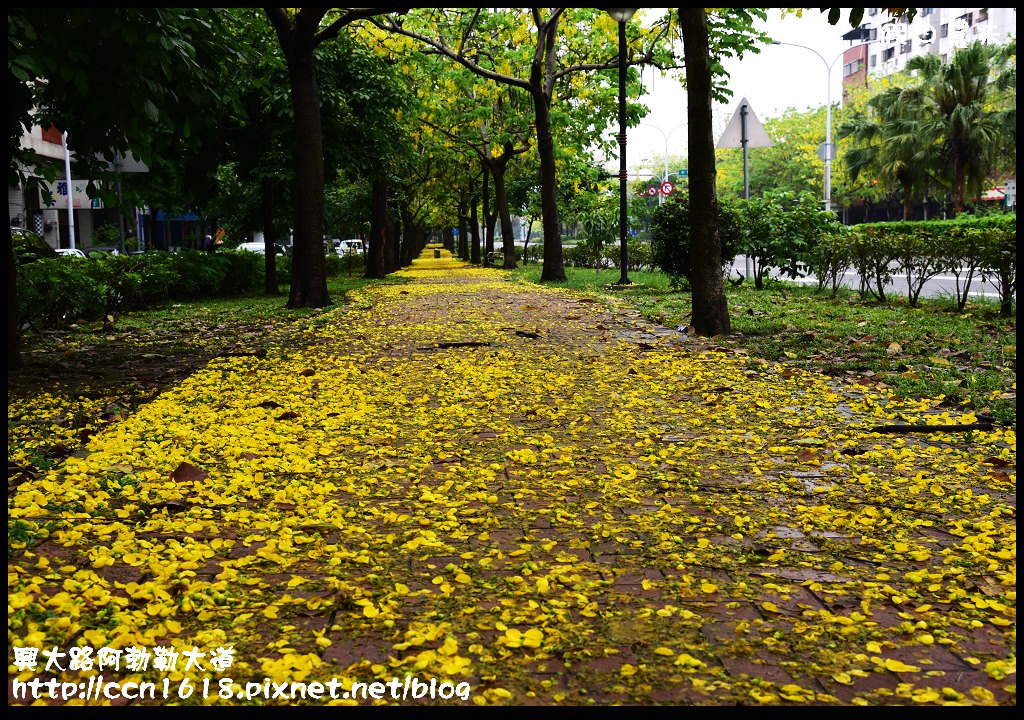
xmin=650 ymin=193 xmax=741 ymax=288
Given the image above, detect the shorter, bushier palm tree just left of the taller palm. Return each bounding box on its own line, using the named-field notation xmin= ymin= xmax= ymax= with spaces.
xmin=838 ymin=87 xmax=935 ymax=220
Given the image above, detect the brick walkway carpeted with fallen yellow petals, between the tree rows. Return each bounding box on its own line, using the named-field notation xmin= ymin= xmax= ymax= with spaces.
xmin=8 ymin=250 xmax=1016 ymax=706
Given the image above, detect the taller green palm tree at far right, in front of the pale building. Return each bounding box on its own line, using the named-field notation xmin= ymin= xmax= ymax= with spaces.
xmin=906 ymin=40 xmax=1017 ymax=213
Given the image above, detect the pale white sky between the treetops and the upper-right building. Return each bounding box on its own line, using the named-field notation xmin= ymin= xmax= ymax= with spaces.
xmin=611 ymin=8 xmax=851 ymax=173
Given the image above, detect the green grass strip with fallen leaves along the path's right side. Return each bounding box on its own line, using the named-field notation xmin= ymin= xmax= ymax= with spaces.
xmin=514 ymin=264 xmax=1017 ymax=424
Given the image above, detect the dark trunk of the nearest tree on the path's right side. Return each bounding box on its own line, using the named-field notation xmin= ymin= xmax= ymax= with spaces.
xmin=679 ymin=7 xmax=731 ymax=336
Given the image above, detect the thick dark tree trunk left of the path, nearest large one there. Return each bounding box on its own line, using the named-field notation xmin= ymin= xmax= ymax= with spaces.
xmin=285 ymin=47 xmax=331 ymax=307
